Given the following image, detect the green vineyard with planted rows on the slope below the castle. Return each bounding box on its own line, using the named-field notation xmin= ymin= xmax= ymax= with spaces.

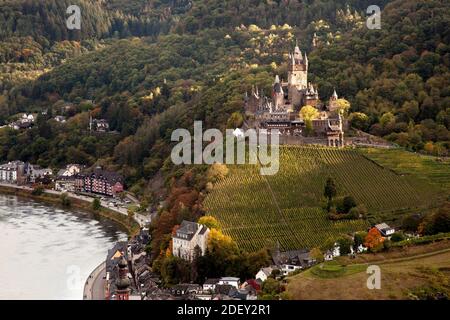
xmin=204 ymin=146 xmax=442 ymax=250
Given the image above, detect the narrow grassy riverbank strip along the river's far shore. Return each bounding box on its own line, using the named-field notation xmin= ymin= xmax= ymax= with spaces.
xmin=0 ymin=183 xmax=140 ymax=236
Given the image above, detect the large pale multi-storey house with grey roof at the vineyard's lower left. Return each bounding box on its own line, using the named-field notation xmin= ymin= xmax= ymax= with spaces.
xmin=172 ymin=221 xmax=209 ymax=261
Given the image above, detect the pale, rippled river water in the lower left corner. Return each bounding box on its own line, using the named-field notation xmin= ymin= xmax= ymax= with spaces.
xmin=0 ymin=194 xmax=127 ymax=300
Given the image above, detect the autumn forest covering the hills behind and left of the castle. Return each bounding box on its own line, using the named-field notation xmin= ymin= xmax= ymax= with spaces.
xmin=0 ymin=0 xmax=450 ymax=274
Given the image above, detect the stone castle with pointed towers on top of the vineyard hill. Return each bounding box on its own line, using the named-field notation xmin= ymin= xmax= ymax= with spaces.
xmin=245 ymin=44 xmax=347 ymax=147
